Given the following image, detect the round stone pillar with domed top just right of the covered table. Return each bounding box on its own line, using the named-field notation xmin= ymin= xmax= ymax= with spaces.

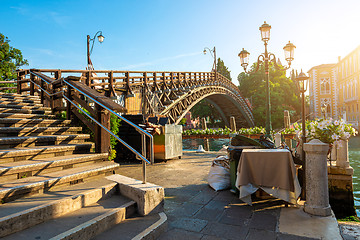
xmin=304 ymin=139 xmax=331 ymax=217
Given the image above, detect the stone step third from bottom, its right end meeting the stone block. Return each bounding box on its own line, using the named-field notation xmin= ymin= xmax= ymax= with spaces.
xmin=0 ymin=178 xmax=130 ymax=239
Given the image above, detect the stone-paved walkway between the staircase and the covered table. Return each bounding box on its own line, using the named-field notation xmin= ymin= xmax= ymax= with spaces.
xmin=120 ymin=152 xmax=342 ymax=240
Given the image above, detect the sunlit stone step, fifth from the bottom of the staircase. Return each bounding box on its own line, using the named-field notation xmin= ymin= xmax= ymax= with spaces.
xmin=0 ymin=153 xmax=108 ymax=182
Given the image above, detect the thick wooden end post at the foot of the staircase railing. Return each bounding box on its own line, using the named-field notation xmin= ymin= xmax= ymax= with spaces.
xmin=94 ymin=104 xmax=110 ymax=153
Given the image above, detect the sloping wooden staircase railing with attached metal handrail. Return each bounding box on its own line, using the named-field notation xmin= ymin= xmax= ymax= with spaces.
xmin=17 ymin=69 xmax=154 ymax=183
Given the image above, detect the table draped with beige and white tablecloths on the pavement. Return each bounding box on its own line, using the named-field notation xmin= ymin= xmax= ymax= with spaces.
xmin=236 ymin=149 xmax=301 ymax=205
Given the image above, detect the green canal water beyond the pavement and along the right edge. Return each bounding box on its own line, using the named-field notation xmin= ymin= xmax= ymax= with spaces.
xmin=183 ymin=135 xmax=360 ymax=216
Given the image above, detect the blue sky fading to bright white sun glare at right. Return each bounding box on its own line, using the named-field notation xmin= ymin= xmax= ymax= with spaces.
xmin=0 ymin=0 xmax=360 ymax=84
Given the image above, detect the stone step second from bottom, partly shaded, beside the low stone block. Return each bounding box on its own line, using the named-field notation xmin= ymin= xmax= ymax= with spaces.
xmin=3 ymin=195 xmax=136 ymax=240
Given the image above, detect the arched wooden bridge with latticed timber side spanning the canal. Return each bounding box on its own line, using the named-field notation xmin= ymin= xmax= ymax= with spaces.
xmin=17 ymin=69 xmax=254 ymax=127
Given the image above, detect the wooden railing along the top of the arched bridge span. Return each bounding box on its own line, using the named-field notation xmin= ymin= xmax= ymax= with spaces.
xmin=18 ymin=69 xmax=253 ymax=124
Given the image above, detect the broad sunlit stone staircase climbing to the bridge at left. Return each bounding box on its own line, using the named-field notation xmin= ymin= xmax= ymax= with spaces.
xmin=0 ymin=93 xmax=167 ymax=239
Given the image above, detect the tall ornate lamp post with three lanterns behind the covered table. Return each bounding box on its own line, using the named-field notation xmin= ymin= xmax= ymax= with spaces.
xmin=238 ymin=22 xmax=295 ymax=138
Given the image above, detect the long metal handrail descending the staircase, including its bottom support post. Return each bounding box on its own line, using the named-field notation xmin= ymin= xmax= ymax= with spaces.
xmin=24 ymin=70 xmax=154 ymax=183
